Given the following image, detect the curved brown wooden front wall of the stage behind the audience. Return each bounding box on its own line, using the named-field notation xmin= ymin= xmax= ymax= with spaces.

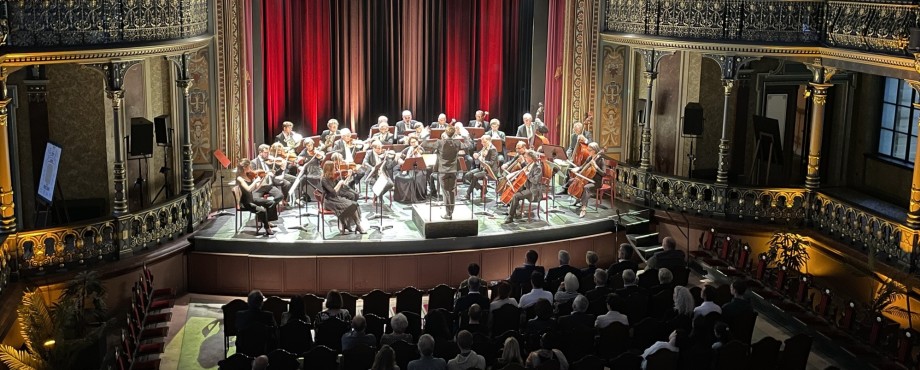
xmin=188 ymin=218 xmax=626 ymax=296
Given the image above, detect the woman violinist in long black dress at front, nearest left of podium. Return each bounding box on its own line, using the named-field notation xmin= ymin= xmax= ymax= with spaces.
xmin=321 ymin=161 xmax=365 ymax=234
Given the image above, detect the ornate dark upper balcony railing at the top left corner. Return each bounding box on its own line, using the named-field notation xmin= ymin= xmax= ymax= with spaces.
xmin=0 ymin=0 xmax=209 ymax=48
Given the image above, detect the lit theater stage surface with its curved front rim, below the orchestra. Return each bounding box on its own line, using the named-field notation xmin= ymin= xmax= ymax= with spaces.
xmin=192 ymin=189 xmax=648 ymax=256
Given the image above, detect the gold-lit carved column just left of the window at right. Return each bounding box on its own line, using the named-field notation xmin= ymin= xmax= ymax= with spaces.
xmin=805 ymin=59 xmax=837 ymax=190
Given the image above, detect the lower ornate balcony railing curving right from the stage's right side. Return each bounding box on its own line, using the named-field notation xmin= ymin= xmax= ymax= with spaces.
xmin=616 ymin=163 xmax=908 ymax=266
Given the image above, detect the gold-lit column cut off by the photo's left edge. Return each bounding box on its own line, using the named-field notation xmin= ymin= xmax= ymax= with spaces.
xmin=0 ymin=68 xmax=16 ymax=234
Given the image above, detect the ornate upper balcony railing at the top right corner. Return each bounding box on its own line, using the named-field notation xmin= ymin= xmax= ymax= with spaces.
xmin=605 ymin=0 xmax=920 ymax=55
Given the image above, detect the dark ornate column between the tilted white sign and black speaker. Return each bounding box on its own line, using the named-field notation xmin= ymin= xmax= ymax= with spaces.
xmin=89 ymin=60 xmax=140 ymax=217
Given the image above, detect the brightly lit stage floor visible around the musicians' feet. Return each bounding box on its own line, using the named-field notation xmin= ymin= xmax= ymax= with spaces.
xmin=193 ymin=188 xmax=641 ymax=254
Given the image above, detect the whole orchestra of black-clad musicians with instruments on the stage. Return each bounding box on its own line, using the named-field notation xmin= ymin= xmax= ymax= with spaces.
xmin=237 ymin=110 xmax=608 ymax=235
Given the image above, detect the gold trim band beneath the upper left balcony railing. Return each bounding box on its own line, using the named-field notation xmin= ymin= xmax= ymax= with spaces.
xmin=0 ymin=36 xmax=213 ymax=67
